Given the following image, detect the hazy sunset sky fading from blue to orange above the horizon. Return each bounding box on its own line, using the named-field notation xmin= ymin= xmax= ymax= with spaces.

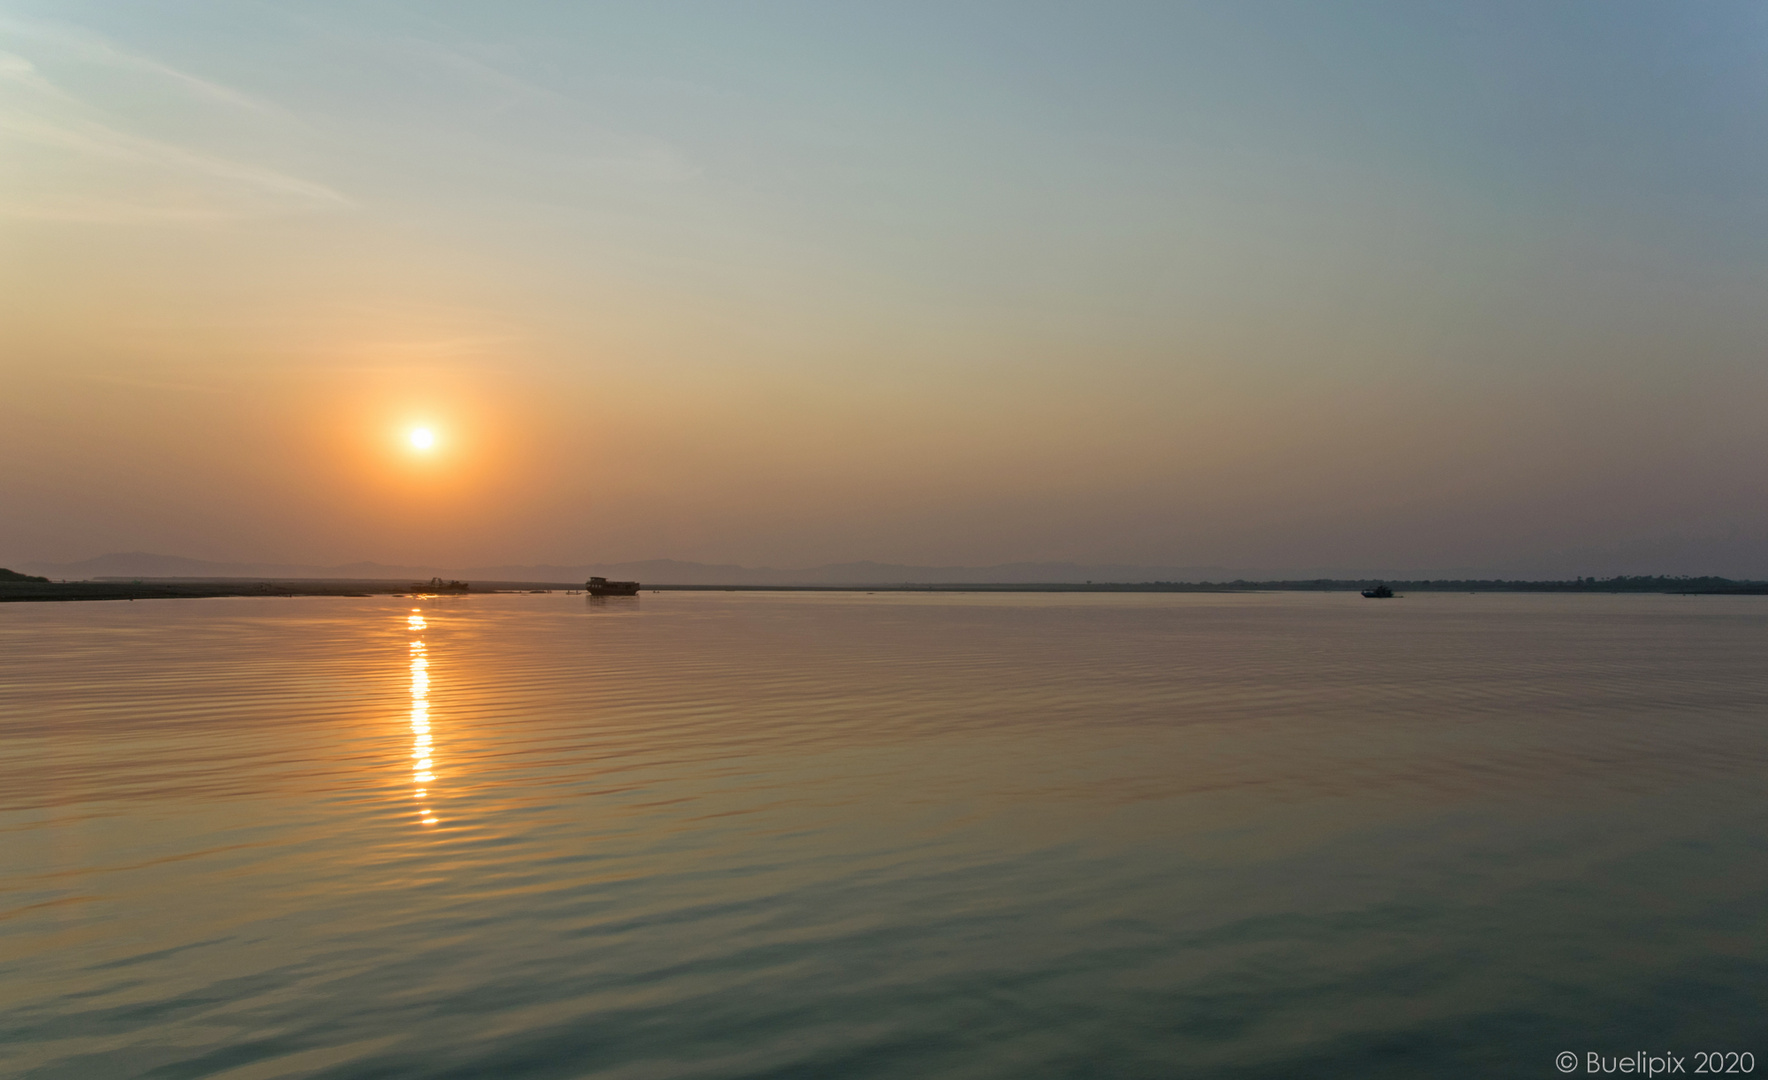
xmin=0 ymin=0 xmax=1768 ymax=573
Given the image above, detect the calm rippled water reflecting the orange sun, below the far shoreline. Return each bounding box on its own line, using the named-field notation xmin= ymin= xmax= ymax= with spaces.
xmin=0 ymin=594 xmax=1768 ymax=1080
